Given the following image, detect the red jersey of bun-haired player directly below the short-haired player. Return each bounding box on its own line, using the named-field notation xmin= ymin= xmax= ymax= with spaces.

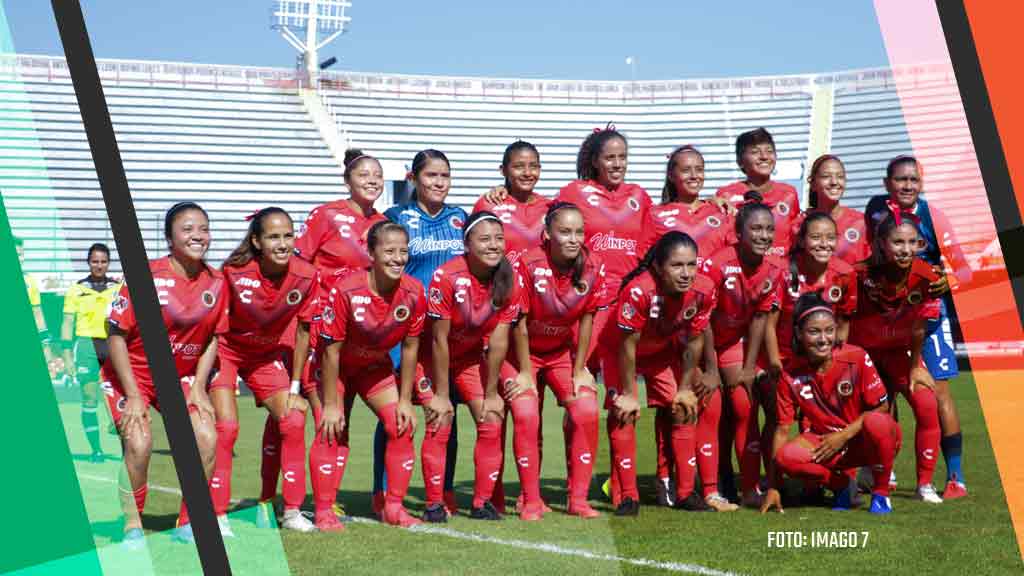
xmin=701 ymin=246 xmax=787 ymax=351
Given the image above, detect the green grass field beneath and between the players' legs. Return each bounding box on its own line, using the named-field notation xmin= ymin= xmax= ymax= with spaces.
xmin=62 ymin=374 xmax=1024 ymax=575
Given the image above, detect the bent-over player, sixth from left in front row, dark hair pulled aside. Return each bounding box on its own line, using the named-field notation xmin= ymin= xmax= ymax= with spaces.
xmin=600 ymin=231 xmax=716 ymax=516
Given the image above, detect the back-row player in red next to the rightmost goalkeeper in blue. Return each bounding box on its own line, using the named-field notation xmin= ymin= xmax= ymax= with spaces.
xmin=793 ymin=154 xmax=871 ymax=265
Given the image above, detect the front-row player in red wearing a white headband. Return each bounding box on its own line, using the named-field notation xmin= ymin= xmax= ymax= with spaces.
xmin=423 ymin=212 xmax=544 ymax=520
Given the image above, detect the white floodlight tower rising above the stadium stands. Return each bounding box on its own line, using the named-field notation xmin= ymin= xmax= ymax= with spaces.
xmin=270 ymin=0 xmax=352 ymax=84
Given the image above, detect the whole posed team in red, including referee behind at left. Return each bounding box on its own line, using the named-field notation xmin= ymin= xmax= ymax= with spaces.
xmin=75 ymin=125 xmax=971 ymax=545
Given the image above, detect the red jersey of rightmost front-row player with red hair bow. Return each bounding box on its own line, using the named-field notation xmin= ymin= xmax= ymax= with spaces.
xmin=850 ymin=258 xmax=942 ymax=351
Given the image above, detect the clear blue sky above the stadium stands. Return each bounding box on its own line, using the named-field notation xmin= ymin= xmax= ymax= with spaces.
xmin=3 ymin=0 xmax=888 ymax=80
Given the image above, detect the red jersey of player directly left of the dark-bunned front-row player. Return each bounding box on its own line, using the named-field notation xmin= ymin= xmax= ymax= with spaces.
xmin=602 ymin=272 xmax=717 ymax=358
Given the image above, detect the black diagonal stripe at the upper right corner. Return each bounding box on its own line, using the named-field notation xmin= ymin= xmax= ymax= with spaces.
xmin=935 ymin=0 xmax=1024 ymax=325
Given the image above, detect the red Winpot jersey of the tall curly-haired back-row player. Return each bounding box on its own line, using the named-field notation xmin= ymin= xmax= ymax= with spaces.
xmin=557 ymin=180 xmax=651 ymax=298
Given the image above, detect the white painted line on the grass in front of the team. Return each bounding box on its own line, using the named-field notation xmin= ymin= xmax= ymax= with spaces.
xmin=78 ymin=472 xmax=736 ymax=576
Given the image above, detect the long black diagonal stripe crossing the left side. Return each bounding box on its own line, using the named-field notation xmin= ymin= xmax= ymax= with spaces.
xmin=51 ymin=0 xmax=230 ymax=576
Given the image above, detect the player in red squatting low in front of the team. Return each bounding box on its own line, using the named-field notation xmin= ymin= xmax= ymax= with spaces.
xmin=761 ymin=292 xmax=900 ymax=515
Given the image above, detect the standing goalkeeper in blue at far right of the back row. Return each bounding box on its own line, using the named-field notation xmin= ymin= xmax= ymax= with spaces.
xmin=864 ymin=156 xmax=972 ymax=499
